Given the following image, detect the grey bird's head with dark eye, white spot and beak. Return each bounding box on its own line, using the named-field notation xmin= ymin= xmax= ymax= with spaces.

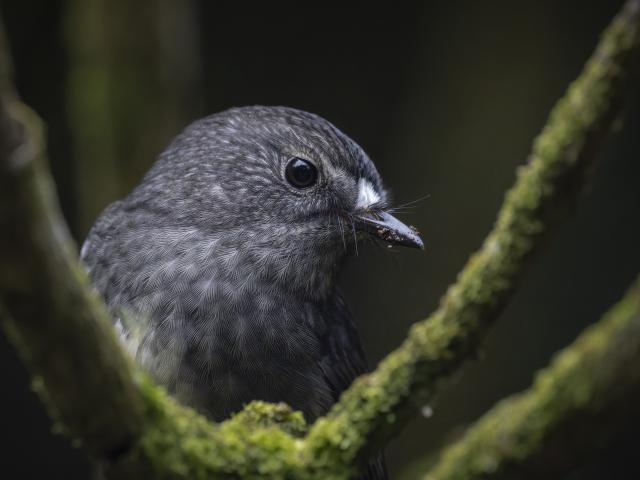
xmin=131 ymin=107 xmax=423 ymax=298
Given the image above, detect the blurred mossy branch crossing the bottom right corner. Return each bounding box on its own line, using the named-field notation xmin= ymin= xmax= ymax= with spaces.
xmin=425 ymin=280 xmax=640 ymax=480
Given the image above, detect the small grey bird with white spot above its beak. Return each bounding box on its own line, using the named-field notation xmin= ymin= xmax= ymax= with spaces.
xmin=81 ymin=106 xmax=422 ymax=478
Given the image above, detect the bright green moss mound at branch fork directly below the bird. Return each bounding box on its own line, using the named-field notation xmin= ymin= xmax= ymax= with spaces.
xmin=107 ymin=374 xmax=318 ymax=479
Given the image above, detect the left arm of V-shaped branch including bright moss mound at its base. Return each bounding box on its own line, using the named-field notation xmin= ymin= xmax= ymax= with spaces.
xmin=0 ymin=13 xmax=306 ymax=479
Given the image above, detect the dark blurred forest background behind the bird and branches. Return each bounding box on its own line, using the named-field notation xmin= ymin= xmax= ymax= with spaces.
xmin=0 ymin=0 xmax=640 ymax=479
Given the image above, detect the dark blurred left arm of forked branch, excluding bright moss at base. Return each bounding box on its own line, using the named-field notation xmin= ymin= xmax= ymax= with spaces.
xmin=0 ymin=19 xmax=142 ymax=462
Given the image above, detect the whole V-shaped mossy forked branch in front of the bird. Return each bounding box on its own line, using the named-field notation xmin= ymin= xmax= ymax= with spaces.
xmin=0 ymin=0 xmax=640 ymax=479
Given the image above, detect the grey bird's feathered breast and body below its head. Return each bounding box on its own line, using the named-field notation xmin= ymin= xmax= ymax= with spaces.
xmin=87 ymin=227 xmax=334 ymax=419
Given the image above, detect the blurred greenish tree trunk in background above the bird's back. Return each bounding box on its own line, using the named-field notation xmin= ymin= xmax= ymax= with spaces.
xmin=65 ymin=0 xmax=201 ymax=235
